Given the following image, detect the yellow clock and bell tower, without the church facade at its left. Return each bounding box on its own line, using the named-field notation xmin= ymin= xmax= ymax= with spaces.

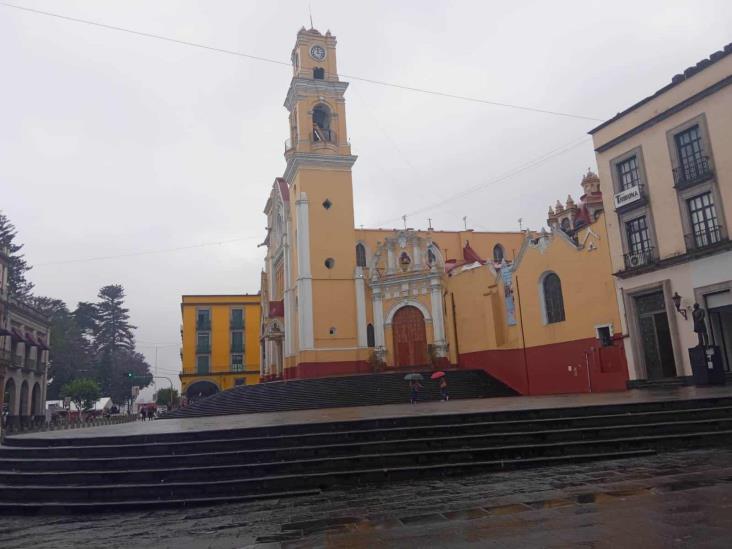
xmin=284 ymin=28 xmax=358 ymax=377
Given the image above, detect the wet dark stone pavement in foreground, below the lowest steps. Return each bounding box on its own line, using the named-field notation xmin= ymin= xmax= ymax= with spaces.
xmin=0 ymin=448 xmax=732 ymax=549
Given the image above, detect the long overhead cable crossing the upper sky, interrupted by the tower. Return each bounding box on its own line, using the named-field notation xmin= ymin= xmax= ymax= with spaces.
xmin=0 ymin=2 xmax=605 ymax=122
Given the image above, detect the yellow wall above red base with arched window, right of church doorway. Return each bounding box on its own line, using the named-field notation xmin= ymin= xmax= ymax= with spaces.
xmin=445 ymin=212 xmax=621 ymax=354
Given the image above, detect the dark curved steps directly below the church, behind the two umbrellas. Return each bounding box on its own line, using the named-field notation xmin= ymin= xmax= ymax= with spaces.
xmin=163 ymin=370 xmax=517 ymax=418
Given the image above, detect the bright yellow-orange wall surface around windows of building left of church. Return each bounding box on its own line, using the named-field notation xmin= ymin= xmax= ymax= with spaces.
xmin=181 ymin=295 xmax=261 ymax=393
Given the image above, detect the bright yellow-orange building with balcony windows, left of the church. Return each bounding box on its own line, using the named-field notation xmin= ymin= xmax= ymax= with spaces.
xmin=180 ymin=294 xmax=261 ymax=399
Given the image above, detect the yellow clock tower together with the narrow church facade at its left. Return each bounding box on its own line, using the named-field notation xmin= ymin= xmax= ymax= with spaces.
xmin=263 ymin=28 xmax=367 ymax=377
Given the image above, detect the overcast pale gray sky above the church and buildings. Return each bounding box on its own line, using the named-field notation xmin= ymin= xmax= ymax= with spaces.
xmin=0 ymin=0 xmax=732 ymax=383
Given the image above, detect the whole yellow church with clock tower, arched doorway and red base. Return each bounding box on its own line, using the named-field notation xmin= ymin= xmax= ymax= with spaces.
xmin=260 ymin=28 xmax=627 ymax=394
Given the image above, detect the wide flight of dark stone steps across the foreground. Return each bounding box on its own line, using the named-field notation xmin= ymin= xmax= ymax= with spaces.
xmin=0 ymin=397 xmax=732 ymax=513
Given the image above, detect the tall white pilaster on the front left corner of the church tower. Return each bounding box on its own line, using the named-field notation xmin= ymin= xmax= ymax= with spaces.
xmin=296 ymin=193 xmax=314 ymax=350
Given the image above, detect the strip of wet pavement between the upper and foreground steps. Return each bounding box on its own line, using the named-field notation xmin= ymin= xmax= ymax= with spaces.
xmin=14 ymin=386 xmax=732 ymax=439
